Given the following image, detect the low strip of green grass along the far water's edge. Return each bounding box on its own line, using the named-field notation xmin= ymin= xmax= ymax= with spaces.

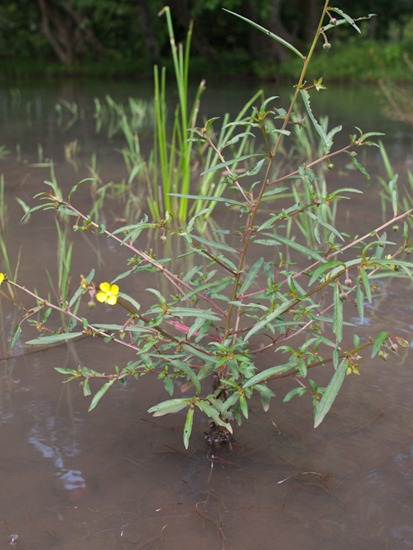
xmin=0 ymin=39 xmax=413 ymax=82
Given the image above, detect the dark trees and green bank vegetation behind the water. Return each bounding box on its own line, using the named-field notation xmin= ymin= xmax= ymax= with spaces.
xmin=0 ymin=0 xmax=413 ymax=80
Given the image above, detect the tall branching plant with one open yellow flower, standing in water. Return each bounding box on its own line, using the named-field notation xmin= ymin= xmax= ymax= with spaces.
xmin=2 ymin=0 xmax=413 ymax=447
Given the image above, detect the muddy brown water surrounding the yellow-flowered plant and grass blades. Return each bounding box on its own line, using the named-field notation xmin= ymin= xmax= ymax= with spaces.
xmin=0 ymin=83 xmax=413 ymax=550
